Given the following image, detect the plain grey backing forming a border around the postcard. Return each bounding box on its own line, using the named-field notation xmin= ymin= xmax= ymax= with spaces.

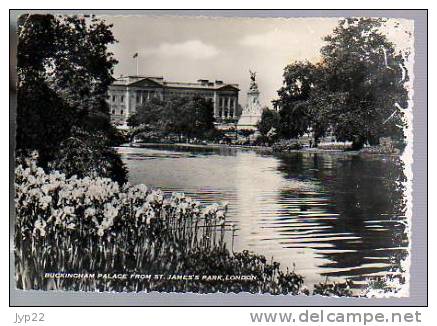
xmin=9 ymin=10 xmax=428 ymax=306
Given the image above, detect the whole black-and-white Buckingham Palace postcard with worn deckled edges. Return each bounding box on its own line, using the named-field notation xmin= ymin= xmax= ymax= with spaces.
xmin=12 ymin=12 xmax=425 ymax=304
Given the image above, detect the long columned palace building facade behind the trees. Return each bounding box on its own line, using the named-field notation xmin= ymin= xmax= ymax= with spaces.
xmin=108 ymin=76 xmax=241 ymax=125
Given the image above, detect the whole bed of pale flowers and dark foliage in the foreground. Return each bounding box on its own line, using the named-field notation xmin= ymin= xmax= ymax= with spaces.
xmin=15 ymin=163 xmax=303 ymax=294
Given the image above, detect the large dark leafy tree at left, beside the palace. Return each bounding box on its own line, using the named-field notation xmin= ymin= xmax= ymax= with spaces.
xmin=16 ymin=14 xmax=125 ymax=181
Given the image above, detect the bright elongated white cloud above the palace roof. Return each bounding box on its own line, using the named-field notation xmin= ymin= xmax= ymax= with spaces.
xmin=142 ymin=40 xmax=219 ymax=59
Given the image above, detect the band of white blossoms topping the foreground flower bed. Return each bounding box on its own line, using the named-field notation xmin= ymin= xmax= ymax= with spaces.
xmin=15 ymin=164 xmax=227 ymax=238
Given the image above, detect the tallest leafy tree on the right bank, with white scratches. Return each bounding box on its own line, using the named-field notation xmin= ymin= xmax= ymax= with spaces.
xmin=320 ymin=18 xmax=408 ymax=149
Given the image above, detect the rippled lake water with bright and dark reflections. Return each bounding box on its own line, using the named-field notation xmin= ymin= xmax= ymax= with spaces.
xmin=118 ymin=145 xmax=408 ymax=284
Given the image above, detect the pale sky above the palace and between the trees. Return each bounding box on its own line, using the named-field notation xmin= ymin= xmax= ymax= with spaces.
xmin=101 ymin=15 xmax=412 ymax=106
